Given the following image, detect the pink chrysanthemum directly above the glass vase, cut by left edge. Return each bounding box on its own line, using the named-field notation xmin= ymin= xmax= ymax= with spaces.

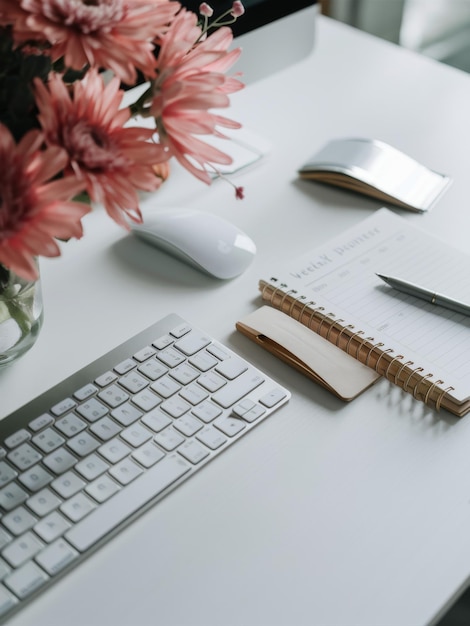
xmin=0 ymin=124 xmax=90 ymax=279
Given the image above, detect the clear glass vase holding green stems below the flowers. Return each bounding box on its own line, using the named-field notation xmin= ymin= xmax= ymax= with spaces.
xmin=0 ymin=264 xmax=43 ymax=367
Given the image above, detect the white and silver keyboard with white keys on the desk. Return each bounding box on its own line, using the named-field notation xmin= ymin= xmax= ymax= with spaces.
xmin=0 ymin=314 xmax=290 ymax=621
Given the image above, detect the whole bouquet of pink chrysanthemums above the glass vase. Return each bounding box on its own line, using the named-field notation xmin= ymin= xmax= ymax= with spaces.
xmin=0 ymin=0 xmax=244 ymax=278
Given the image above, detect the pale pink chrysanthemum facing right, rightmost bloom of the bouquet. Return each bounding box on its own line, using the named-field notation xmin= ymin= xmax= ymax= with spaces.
xmin=151 ymin=9 xmax=244 ymax=183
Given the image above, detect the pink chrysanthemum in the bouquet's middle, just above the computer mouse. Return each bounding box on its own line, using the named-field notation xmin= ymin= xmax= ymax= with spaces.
xmin=35 ymin=69 xmax=169 ymax=227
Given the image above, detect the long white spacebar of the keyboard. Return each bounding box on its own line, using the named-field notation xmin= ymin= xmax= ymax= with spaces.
xmin=65 ymin=454 xmax=191 ymax=552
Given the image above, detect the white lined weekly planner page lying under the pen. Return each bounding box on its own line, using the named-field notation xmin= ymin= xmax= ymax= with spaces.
xmin=267 ymin=208 xmax=470 ymax=401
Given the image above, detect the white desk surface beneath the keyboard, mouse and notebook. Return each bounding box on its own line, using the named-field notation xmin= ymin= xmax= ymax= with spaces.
xmin=0 ymin=17 xmax=470 ymax=626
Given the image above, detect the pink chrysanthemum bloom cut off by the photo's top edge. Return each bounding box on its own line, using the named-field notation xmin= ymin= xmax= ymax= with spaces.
xmin=0 ymin=0 xmax=180 ymax=84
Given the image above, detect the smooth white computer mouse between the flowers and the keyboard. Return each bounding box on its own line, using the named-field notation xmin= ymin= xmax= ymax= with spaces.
xmin=131 ymin=208 xmax=256 ymax=279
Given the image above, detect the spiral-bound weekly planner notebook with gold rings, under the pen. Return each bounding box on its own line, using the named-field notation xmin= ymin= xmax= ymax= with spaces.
xmin=248 ymin=208 xmax=470 ymax=416
